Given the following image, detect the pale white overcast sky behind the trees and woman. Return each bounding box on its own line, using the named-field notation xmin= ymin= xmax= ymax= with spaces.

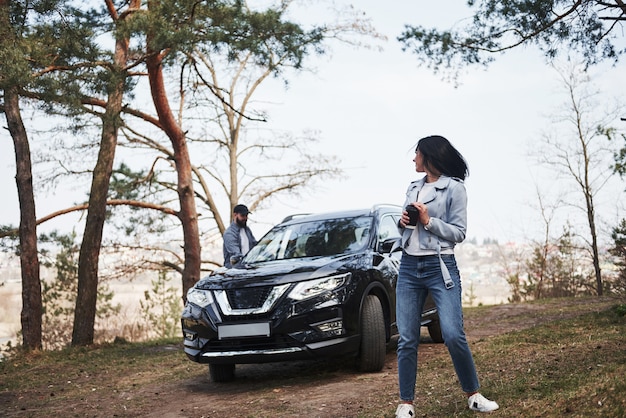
xmin=0 ymin=0 xmax=626 ymax=242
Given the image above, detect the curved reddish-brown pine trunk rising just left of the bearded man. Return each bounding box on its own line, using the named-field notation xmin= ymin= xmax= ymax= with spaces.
xmin=146 ymin=51 xmax=201 ymax=301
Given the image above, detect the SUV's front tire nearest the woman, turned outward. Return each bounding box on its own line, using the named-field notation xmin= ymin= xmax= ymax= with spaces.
xmin=358 ymin=295 xmax=387 ymax=372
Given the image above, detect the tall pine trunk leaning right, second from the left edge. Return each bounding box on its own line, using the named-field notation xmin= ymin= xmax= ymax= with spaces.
xmin=72 ymin=20 xmax=128 ymax=346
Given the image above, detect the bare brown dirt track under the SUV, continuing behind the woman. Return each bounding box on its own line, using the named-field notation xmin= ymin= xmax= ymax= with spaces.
xmin=0 ymin=298 xmax=616 ymax=418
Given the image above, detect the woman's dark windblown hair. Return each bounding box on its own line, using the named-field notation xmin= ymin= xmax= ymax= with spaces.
xmin=415 ymin=135 xmax=469 ymax=180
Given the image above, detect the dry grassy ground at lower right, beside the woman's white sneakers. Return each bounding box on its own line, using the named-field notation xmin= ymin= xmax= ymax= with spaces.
xmin=400 ymin=307 xmax=626 ymax=417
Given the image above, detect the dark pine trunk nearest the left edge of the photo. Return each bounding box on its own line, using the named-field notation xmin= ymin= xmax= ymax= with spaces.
xmin=4 ymin=86 xmax=42 ymax=350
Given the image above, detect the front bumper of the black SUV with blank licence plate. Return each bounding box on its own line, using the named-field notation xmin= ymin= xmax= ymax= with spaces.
xmin=181 ymin=293 xmax=360 ymax=364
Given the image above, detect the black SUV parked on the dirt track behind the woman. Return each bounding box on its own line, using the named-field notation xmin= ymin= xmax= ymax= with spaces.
xmin=182 ymin=205 xmax=443 ymax=382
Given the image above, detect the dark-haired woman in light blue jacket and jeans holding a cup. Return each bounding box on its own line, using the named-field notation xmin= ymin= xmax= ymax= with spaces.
xmin=396 ymin=136 xmax=498 ymax=418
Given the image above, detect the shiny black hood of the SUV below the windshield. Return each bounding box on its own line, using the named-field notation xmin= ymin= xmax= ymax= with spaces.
xmin=195 ymin=254 xmax=363 ymax=289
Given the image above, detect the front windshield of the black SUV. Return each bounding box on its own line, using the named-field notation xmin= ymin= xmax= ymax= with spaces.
xmin=244 ymin=216 xmax=372 ymax=264
